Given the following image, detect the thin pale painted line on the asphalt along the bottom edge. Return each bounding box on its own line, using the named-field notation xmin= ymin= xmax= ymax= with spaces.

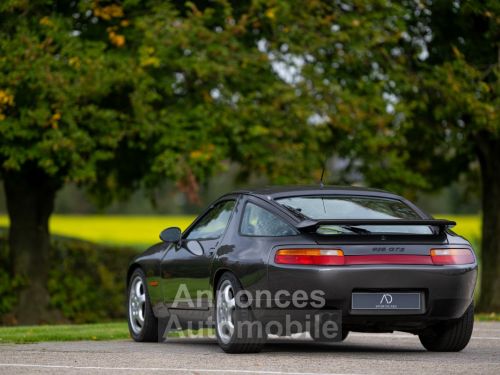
xmin=0 ymin=363 xmax=356 ymax=375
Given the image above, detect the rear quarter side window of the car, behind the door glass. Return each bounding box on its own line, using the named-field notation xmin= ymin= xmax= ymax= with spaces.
xmin=240 ymin=202 xmax=297 ymax=237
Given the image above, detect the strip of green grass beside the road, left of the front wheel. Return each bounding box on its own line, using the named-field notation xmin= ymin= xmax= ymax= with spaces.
xmin=0 ymin=322 xmax=130 ymax=344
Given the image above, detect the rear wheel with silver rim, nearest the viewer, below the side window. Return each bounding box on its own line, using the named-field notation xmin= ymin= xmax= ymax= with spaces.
xmin=215 ymin=272 xmax=265 ymax=353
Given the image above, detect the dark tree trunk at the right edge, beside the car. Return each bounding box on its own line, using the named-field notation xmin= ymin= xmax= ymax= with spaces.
xmin=477 ymin=134 xmax=500 ymax=312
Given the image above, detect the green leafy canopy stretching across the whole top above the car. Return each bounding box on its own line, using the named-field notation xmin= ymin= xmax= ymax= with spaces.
xmin=0 ymin=0 xmax=500 ymax=204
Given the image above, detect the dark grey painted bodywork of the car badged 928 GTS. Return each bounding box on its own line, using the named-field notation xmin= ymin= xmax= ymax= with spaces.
xmin=129 ymin=187 xmax=477 ymax=332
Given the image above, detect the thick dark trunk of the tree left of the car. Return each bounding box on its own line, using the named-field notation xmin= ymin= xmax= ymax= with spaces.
xmin=3 ymin=169 xmax=59 ymax=324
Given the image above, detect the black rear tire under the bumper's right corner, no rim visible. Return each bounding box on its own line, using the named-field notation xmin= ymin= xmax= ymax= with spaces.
xmin=418 ymin=304 xmax=474 ymax=352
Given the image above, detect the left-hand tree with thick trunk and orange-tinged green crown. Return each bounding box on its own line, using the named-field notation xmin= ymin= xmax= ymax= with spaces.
xmin=0 ymin=0 xmax=139 ymax=323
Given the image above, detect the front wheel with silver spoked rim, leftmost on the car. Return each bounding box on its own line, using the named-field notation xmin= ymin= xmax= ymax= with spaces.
xmin=127 ymin=268 xmax=158 ymax=342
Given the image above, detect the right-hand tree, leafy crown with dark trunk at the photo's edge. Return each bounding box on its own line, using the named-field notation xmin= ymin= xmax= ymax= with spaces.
xmin=288 ymin=1 xmax=500 ymax=311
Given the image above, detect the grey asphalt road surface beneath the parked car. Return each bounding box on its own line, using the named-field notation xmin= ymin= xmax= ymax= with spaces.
xmin=0 ymin=322 xmax=500 ymax=375
